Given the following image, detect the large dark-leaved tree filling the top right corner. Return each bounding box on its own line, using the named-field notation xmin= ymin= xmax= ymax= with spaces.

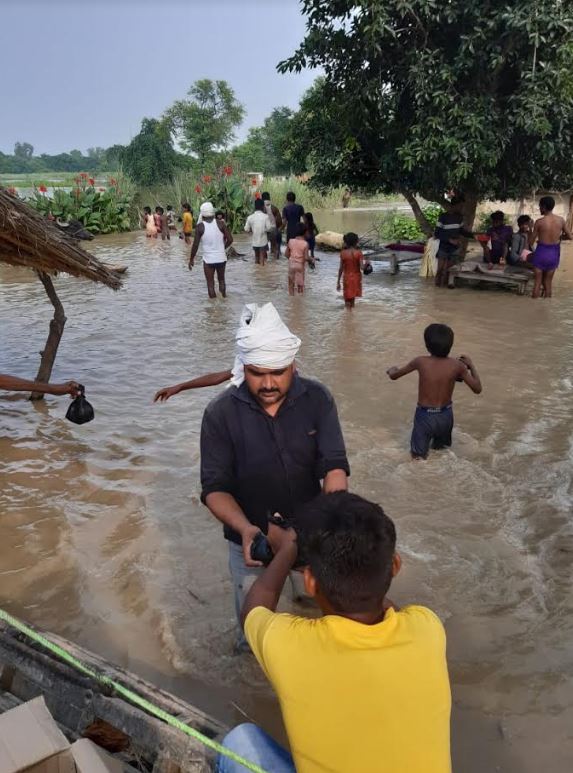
xmin=278 ymin=0 xmax=573 ymax=232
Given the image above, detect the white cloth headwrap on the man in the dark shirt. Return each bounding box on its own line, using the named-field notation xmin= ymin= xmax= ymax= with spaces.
xmin=231 ymin=303 xmax=301 ymax=387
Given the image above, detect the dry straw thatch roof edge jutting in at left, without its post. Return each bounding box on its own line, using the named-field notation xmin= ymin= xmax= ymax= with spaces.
xmin=0 ymin=188 xmax=121 ymax=290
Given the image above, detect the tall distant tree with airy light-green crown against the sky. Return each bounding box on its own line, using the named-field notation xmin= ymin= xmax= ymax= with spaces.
xmin=164 ymin=78 xmax=245 ymax=167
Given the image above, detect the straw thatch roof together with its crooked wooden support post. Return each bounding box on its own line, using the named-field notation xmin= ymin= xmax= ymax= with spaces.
xmin=0 ymin=188 xmax=121 ymax=399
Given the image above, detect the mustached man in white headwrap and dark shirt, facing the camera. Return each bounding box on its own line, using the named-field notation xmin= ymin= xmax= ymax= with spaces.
xmin=201 ymin=303 xmax=350 ymax=643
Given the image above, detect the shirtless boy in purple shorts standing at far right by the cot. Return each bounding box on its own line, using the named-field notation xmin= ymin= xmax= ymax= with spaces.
xmin=531 ymin=196 xmax=573 ymax=298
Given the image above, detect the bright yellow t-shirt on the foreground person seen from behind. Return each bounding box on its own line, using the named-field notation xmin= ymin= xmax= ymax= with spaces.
xmin=245 ymin=606 xmax=451 ymax=773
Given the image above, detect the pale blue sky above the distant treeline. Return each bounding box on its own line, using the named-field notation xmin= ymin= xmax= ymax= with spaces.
xmin=0 ymin=0 xmax=315 ymax=154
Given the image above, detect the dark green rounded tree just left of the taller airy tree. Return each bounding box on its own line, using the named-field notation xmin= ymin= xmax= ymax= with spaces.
xmin=121 ymin=118 xmax=175 ymax=185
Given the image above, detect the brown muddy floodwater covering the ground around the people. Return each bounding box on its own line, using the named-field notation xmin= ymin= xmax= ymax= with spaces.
xmin=0 ymin=211 xmax=573 ymax=773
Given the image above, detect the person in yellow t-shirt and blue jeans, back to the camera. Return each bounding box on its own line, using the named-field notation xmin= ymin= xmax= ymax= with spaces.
xmin=218 ymin=492 xmax=451 ymax=773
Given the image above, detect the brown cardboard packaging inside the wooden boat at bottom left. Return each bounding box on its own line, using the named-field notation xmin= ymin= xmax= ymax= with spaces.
xmin=0 ymin=697 xmax=124 ymax=773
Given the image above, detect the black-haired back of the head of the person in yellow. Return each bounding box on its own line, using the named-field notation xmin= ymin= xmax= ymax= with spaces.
xmin=295 ymin=491 xmax=396 ymax=614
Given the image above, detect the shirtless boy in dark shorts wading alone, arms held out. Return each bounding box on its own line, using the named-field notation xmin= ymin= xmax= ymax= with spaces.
xmin=386 ymin=324 xmax=482 ymax=459
